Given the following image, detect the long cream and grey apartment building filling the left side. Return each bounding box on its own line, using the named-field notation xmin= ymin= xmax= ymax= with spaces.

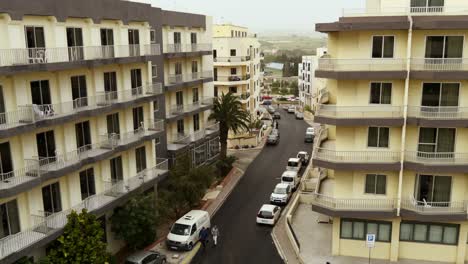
xmin=0 ymin=0 xmax=216 ymax=263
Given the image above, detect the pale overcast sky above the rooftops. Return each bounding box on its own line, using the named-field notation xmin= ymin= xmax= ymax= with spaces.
xmin=131 ymin=0 xmax=365 ymax=33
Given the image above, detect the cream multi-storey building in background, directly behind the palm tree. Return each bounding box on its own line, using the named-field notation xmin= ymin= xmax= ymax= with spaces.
xmin=213 ymin=24 xmax=263 ymax=115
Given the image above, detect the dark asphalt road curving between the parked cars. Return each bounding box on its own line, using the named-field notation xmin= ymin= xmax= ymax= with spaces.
xmin=192 ymin=109 xmax=312 ymax=264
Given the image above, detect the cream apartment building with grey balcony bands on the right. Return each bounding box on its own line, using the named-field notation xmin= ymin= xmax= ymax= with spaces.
xmin=313 ymin=0 xmax=468 ymax=263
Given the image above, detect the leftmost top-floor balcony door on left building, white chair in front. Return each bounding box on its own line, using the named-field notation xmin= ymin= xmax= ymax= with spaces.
xmin=25 ymin=26 xmax=47 ymax=63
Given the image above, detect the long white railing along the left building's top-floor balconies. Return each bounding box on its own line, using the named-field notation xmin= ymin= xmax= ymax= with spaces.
xmin=0 ymin=44 xmax=161 ymax=66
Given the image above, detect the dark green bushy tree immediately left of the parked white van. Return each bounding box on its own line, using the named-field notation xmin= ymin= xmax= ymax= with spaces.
xmin=111 ymin=194 xmax=158 ymax=250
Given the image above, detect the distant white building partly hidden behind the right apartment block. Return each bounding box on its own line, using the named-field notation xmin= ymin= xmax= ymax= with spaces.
xmin=297 ymin=48 xmax=328 ymax=110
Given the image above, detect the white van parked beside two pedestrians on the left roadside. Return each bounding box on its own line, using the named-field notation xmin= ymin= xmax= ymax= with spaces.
xmin=166 ymin=210 xmax=211 ymax=251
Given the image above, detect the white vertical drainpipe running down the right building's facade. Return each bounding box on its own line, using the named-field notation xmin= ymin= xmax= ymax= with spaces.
xmin=397 ymin=14 xmax=413 ymax=216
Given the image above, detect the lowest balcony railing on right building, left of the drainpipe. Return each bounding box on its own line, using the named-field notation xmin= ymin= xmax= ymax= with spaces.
xmin=312 ymin=194 xmax=396 ymax=211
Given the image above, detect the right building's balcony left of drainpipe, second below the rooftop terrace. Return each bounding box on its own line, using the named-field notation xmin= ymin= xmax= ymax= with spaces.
xmin=314 ymin=104 xmax=404 ymax=126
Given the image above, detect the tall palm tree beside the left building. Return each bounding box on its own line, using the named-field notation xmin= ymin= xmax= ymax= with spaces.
xmin=208 ymin=93 xmax=250 ymax=159
